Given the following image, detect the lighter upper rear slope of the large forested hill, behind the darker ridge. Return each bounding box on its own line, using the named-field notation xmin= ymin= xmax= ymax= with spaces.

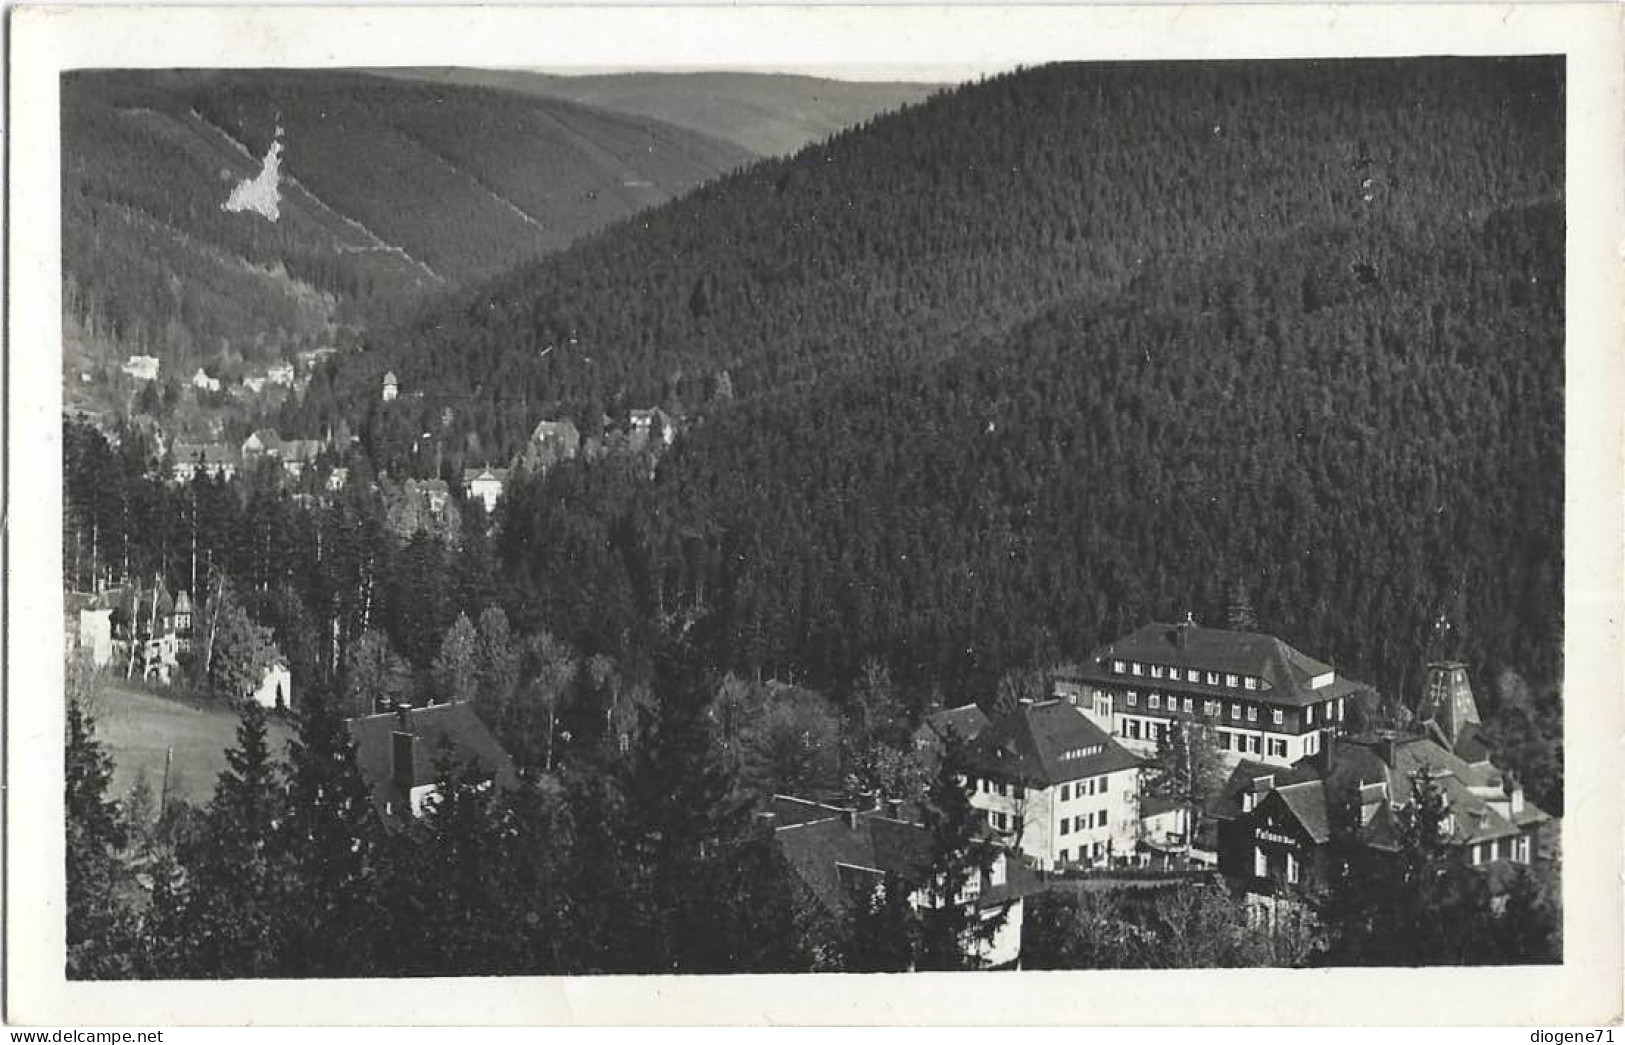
xmin=292 ymin=60 xmax=1562 ymax=455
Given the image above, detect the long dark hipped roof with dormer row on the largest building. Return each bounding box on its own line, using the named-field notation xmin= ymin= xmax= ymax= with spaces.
xmin=1068 ymin=621 xmax=1368 ymax=705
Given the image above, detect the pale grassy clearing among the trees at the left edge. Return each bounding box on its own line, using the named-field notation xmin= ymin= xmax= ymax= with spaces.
xmin=94 ymin=681 xmax=293 ymax=804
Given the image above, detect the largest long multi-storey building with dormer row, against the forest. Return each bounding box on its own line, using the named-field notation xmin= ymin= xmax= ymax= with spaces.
xmin=1055 ymin=614 xmax=1370 ymax=765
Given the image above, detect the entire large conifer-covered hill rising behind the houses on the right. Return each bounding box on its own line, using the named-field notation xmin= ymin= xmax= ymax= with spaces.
xmin=289 ymin=59 xmax=1563 ymax=731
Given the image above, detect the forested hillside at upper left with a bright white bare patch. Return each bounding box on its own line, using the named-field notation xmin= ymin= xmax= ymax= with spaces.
xmin=62 ymin=72 xmax=751 ymax=386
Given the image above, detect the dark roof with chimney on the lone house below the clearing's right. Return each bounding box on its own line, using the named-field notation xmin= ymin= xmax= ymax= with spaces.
xmin=349 ymin=702 xmax=517 ymax=825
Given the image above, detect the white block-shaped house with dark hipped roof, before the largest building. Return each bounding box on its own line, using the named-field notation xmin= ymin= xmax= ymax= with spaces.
xmin=964 ymin=700 xmax=1142 ymax=869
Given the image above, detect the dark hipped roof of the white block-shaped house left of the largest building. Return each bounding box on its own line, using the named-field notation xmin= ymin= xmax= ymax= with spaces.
xmin=965 ymin=700 xmax=1142 ymax=787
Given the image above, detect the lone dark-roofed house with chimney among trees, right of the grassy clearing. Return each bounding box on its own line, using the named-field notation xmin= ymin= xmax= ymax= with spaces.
xmin=349 ymin=702 xmax=518 ymax=826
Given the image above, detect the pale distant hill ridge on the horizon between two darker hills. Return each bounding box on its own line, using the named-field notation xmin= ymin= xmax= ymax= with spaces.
xmin=377 ymin=68 xmax=941 ymax=156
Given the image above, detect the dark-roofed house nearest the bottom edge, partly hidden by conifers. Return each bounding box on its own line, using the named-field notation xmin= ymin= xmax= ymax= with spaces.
xmin=765 ymin=795 xmax=1035 ymax=969
